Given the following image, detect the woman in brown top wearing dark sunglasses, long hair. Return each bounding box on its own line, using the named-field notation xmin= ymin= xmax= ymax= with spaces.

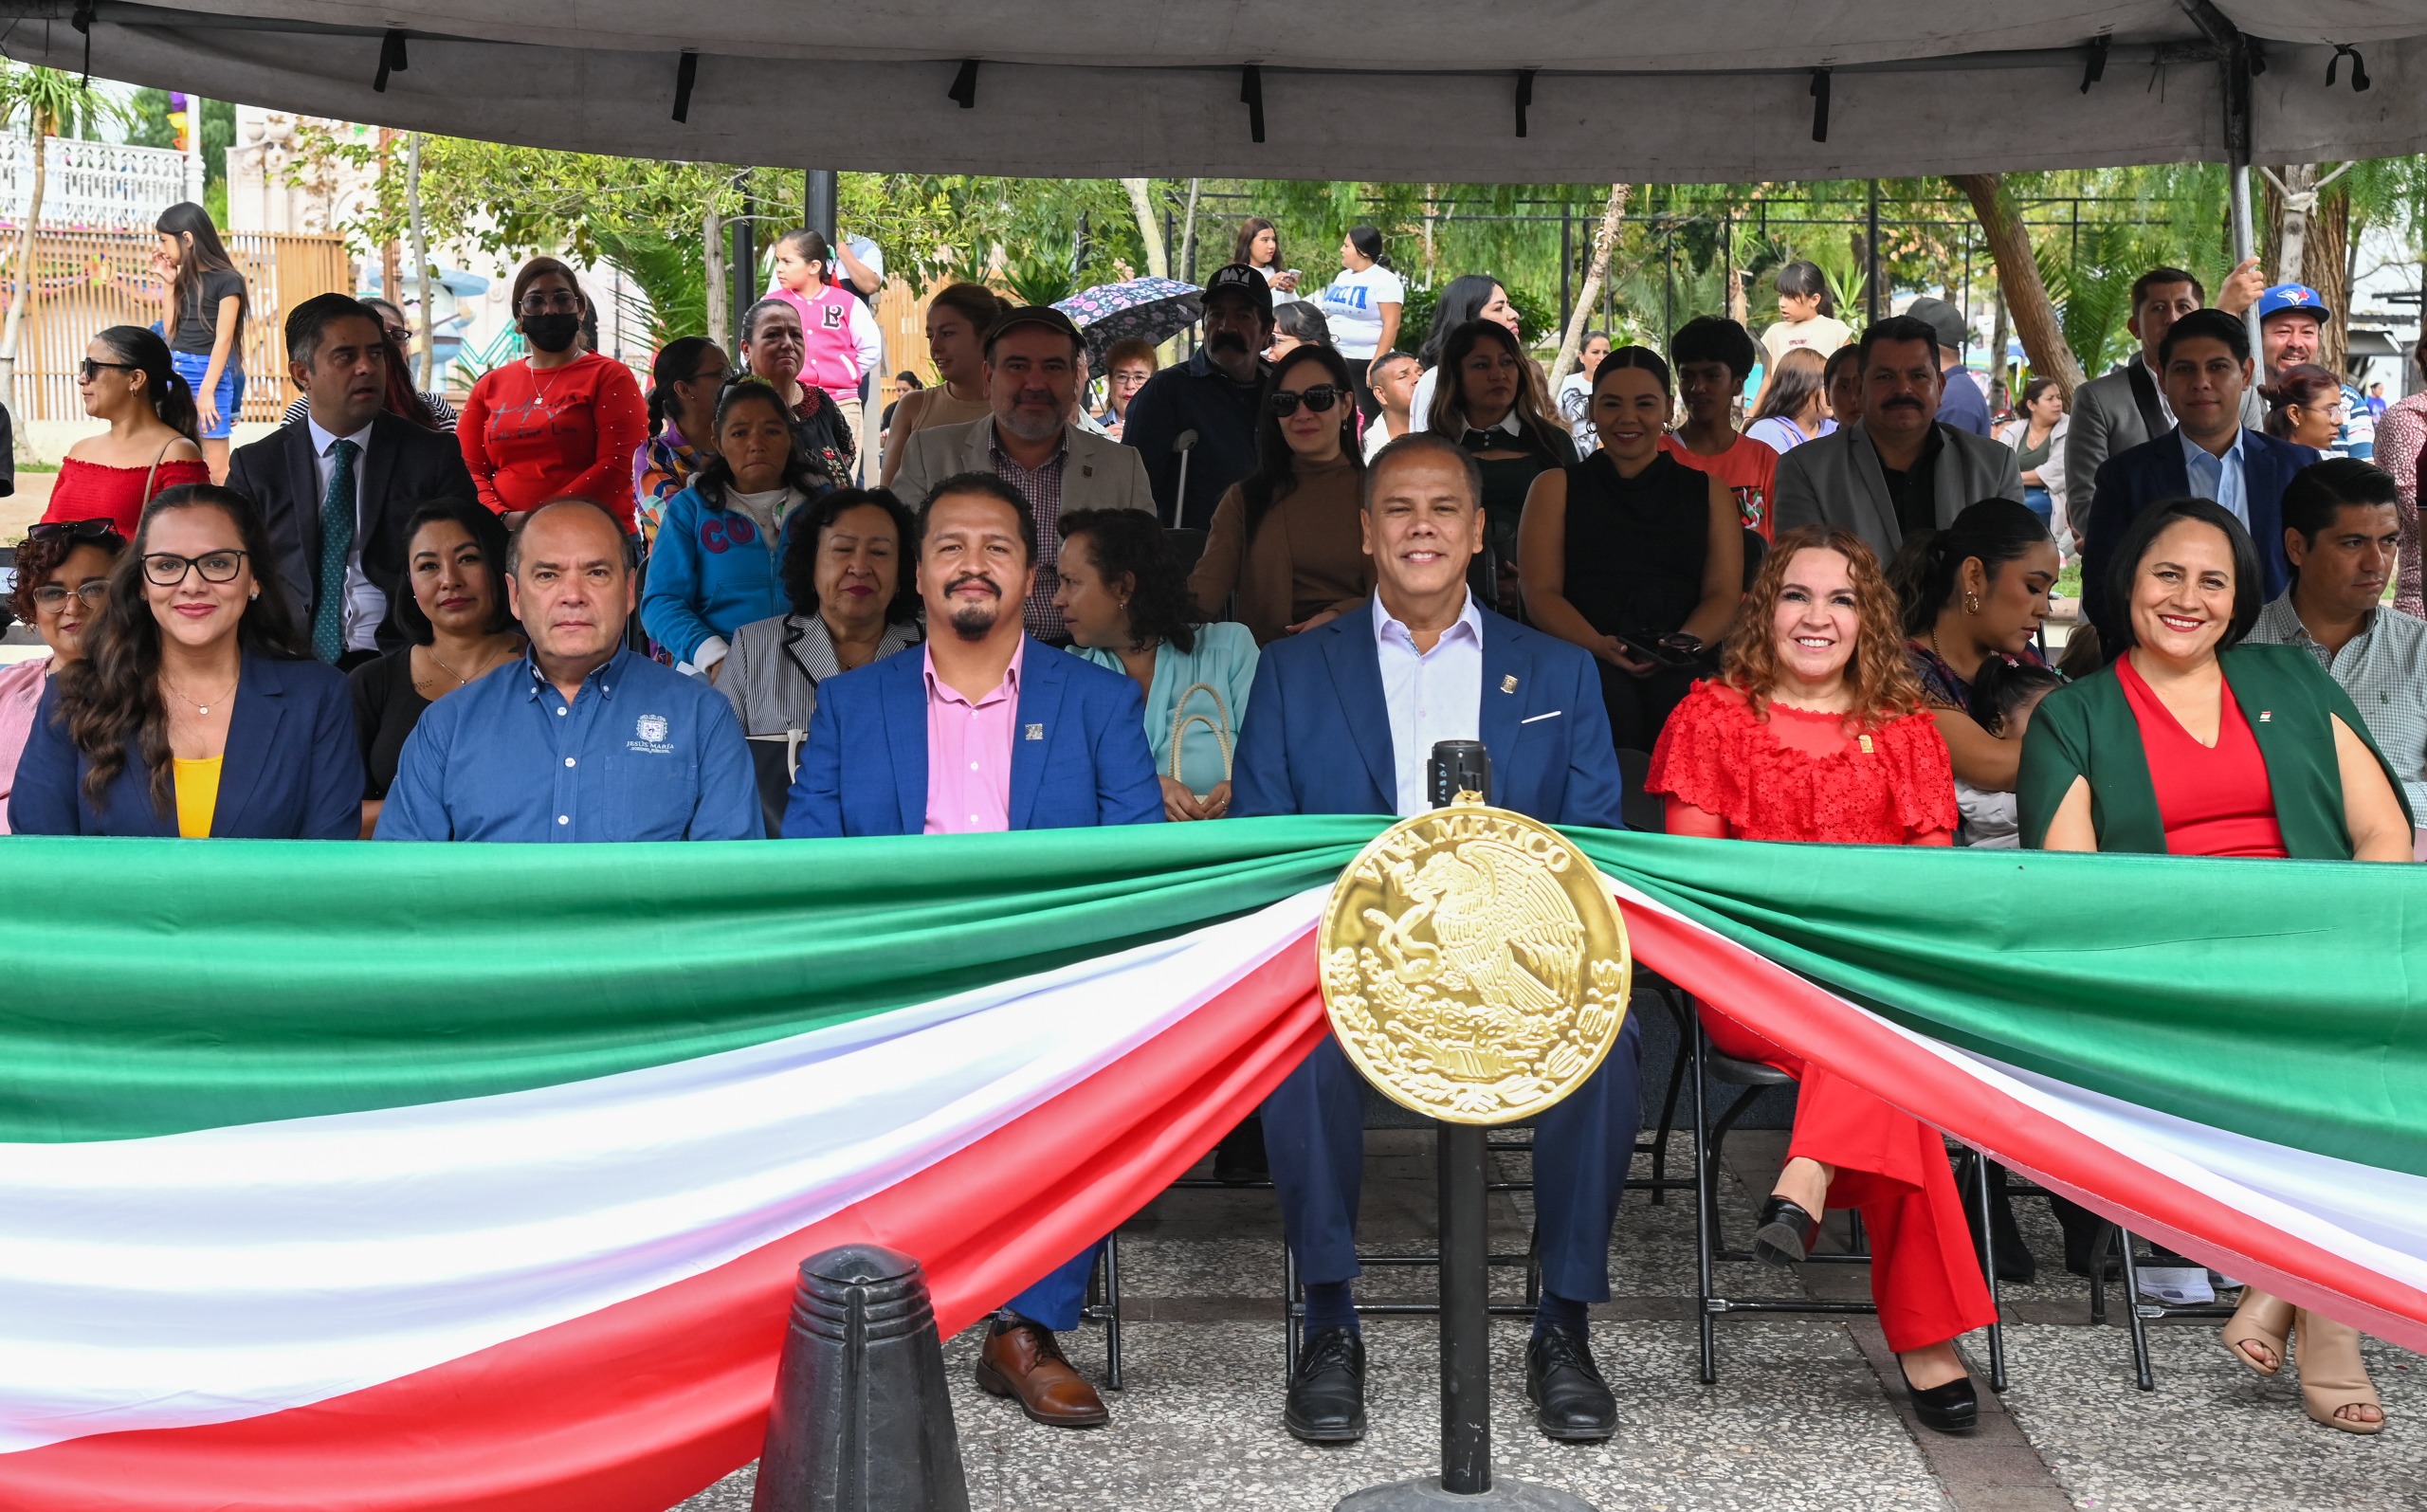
xmin=1189 ymin=347 xmax=1374 ymax=646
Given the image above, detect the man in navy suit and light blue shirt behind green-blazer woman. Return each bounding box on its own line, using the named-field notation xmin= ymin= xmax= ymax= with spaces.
xmin=2082 ymin=311 xmax=2318 ymax=646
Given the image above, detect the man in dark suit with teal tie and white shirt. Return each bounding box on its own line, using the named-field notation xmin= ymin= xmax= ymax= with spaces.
xmin=228 ymin=294 xmax=478 ymax=667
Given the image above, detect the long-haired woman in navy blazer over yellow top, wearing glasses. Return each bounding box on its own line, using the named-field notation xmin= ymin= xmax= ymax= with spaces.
xmin=9 ymin=483 xmax=361 ymax=840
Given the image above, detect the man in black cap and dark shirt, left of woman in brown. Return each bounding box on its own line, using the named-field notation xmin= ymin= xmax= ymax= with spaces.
xmin=1122 ymin=263 xmax=1271 ymax=529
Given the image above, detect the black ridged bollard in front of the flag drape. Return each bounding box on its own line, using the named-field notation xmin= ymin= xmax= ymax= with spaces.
xmin=750 ymin=1245 xmax=968 ymax=1512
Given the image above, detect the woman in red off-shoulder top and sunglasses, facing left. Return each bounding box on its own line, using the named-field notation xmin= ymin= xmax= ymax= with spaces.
xmin=42 ymin=325 xmax=211 ymax=541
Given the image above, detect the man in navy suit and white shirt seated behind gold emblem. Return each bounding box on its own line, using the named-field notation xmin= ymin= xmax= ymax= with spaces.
xmin=1231 ymin=432 xmax=1638 ymax=1444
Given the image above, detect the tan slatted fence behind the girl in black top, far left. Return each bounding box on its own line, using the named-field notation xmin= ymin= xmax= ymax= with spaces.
xmin=0 ymin=228 xmax=355 ymax=422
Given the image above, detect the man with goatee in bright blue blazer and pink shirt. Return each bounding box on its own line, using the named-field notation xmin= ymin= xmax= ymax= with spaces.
xmin=784 ymin=473 xmax=1162 ymax=1427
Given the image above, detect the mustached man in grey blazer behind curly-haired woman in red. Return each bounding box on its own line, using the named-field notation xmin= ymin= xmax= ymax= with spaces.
xmin=1769 ymin=316 xmax=2021 ymax=563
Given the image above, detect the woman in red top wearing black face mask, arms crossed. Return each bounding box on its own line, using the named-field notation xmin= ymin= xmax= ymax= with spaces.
xmin=456 ymin=257 xmax=648 ymax=537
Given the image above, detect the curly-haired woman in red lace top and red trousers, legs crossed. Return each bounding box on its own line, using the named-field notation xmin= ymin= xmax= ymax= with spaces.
xmin=1643 ymin=529 xmax=1995 ymax=1432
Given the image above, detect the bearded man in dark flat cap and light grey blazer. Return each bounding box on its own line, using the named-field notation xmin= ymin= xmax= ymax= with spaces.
xmin=893 ymin=306 xmax=1156 ymax=646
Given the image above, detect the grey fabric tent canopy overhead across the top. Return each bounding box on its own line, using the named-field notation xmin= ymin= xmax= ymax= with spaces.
xmin=0 ymin=0 xmax=2427 ymax=182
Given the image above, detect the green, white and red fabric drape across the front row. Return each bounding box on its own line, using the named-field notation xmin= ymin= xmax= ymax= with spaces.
xmin=0 ymin=818 xmax=2427 ymax=1512
